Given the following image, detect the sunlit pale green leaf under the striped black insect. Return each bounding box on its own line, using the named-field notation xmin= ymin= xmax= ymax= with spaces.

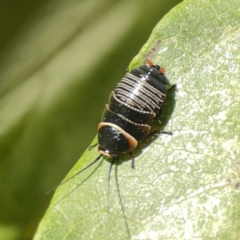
xmin=35 ymin=0 xmax=240 ymax=240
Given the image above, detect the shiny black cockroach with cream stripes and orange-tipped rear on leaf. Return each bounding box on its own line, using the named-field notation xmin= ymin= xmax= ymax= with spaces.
xmin=53 ymin=60 xmax=175 ymax=191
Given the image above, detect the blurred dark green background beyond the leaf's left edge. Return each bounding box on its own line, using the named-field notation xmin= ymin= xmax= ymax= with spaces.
xmin=0 ymin=0 xmax=180 ymax=240
